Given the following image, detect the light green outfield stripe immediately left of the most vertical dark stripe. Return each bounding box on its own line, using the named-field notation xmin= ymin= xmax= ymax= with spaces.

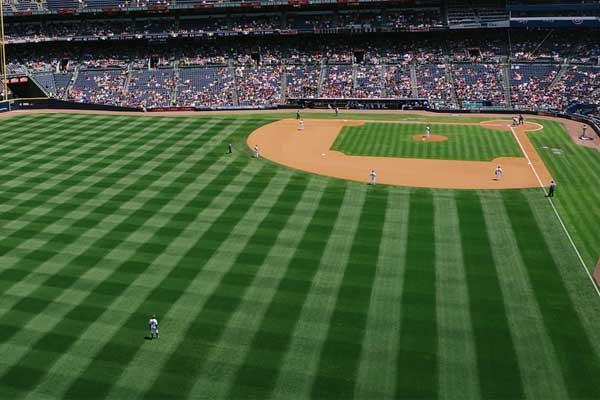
xmin=354 ymin=189 xmax=409 ymax=399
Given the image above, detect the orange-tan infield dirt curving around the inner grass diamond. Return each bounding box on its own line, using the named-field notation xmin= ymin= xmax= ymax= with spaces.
xmin=247 ymin=119 xmax=552 ymax=189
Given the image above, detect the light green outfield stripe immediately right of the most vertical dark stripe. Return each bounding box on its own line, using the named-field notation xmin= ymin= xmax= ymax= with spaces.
xmin=434 ymin=192 xmax=481 ymax=399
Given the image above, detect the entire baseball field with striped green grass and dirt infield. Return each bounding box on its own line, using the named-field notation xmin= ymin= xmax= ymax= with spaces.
xmin=0 ymin=113 xmax=600 ymax=399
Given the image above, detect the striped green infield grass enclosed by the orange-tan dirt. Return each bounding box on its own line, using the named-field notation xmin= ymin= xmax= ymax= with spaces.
xmin=332 ymin=123 xmax=522 ymax=161
